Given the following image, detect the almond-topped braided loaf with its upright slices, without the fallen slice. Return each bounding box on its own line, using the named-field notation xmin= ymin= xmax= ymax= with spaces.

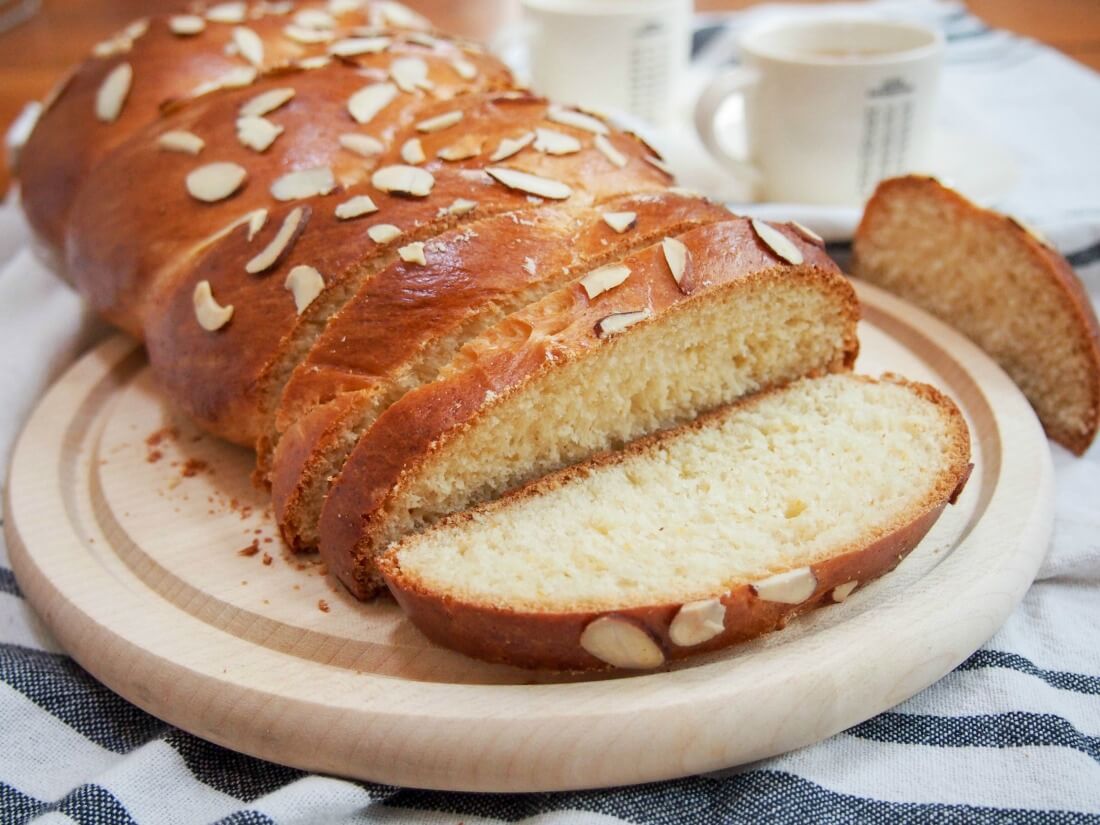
xmin=18 ymin=0 xmax=972 ymax=660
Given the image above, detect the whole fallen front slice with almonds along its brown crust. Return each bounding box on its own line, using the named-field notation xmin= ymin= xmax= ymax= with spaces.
xmin=381 ymin=374 xmax=970 ymax=670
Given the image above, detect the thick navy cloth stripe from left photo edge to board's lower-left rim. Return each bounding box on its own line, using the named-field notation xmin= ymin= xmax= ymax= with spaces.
xmin=0 ymin=645 xmax=168 ymax=754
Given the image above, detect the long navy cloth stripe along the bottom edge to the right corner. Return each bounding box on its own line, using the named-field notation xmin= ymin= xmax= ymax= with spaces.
xmin=385 ymin=770 xmax=1100 ymax=825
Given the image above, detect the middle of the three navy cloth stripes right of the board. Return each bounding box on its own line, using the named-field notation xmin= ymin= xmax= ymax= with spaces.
xmin=846 ymin=711 xmax=1100 ymax=762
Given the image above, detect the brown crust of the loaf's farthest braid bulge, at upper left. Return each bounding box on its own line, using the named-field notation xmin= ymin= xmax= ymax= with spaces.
xmin=17 ymin=1 xmax=433 ymax=258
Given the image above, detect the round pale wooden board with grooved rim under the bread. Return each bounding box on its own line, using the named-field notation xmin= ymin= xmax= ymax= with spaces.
xmin=6 ymin=285 xmax=1053 ymax=791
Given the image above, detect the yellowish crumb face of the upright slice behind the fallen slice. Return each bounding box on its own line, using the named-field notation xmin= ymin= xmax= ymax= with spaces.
xmin=375 ymin=275 xmax=849 ymax=550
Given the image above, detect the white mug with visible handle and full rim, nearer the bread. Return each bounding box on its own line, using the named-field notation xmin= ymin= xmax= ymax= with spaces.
xmin=695 ymin=19 xmax=944 ymax=204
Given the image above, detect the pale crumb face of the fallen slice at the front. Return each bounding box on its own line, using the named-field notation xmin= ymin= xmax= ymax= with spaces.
xmin=395 ymin=375 xmax=965 ymax=612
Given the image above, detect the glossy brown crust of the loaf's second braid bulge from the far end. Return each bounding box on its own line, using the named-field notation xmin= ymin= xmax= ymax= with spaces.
xmin=67 ymin=36 xmax=510 ymax=337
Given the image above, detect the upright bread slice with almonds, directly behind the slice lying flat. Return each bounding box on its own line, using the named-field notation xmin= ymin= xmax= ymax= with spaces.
xmin=319 ymin=218 xmax=859 ymax=596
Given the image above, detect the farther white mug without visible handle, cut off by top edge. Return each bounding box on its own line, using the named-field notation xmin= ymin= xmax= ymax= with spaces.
xmin=524 ymin=0 xmax=692 ymax=123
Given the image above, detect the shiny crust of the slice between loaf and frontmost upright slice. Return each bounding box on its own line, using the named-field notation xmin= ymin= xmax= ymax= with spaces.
xmin=271 ymin=194 xmax=730 ymax=549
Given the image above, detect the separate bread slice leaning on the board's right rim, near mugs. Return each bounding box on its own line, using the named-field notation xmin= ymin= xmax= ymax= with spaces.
xmin=854 ymin=176 xmax=1100 ymax=454
